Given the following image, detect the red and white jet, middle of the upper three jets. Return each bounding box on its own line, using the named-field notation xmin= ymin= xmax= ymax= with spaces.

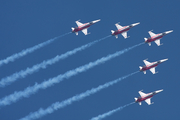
xmin=111 ymin=22 xmax=140 ymax=39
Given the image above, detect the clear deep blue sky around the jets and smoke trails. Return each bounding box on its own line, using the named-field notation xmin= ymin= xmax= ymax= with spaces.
xmin=0 ymin=0 xmax=180 ymax=120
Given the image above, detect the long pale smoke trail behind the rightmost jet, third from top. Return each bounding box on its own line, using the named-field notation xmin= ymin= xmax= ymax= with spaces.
xmin=0 ymin=42 xmax=144 ymax=106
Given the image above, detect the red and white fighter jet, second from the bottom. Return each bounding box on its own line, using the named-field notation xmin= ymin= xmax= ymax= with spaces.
xmin=139 ymin=59 xmax=168 ymax=74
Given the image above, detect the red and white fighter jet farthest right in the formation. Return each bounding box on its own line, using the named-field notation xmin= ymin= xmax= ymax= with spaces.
xmin=144 ymin=30 xmax=173 ymax=46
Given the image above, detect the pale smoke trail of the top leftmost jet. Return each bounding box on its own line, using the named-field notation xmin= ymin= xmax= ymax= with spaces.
xmin=0 ymin=32 xmax=71 ymax=66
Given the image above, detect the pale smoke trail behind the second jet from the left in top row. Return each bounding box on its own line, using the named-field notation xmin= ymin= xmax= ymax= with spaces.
xmin=0 ymin=35 xmax=111 ymax=87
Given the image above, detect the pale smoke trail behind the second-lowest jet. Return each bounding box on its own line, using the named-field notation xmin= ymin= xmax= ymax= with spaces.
xmin=20 ymin=71 xmax=139 ymax=120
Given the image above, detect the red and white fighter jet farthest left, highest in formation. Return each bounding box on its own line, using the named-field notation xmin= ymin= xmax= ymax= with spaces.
xmin=71 ymin=19 xmax=100 ymax=35
